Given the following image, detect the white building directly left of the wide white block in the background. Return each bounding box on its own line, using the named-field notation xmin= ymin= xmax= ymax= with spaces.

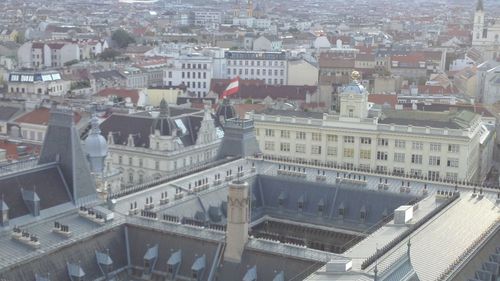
xmin=163 ymin=54 xmax=213 ymax=97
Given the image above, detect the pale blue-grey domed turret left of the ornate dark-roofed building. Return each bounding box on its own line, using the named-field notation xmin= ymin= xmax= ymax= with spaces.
xmin=85 ymin=115 xmax=108 ymax=173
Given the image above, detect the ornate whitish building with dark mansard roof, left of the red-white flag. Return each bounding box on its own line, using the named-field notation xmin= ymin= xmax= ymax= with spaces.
xmin=101 ymin=101 xmax=224 ymax=184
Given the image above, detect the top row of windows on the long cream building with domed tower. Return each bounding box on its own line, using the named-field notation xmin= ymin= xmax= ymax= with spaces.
xmin=257 ymin=129 xmax=460 ymax=153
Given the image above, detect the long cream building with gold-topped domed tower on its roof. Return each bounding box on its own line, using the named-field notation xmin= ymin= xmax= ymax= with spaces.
xmin=248 ymin=72 xmax=494 ymax=181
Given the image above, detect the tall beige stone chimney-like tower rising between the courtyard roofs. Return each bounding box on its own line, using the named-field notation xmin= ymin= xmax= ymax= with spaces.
xmin=224 ymin=181 xmax=250 ymax=263
